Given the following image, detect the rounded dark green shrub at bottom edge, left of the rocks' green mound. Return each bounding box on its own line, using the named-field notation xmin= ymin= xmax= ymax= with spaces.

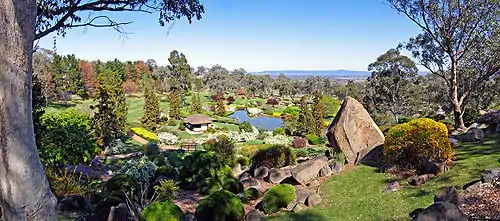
xmin=195 ymin=190 xmax=245 ymax=221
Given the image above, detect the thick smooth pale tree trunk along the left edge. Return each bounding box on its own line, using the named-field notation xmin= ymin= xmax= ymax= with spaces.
xmin=0 ymin=0 xmax=57 ymax=221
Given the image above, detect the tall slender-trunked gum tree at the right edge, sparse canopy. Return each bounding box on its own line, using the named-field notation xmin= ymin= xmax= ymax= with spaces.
xmin=388 ymin=0 xmax=500 ymax=128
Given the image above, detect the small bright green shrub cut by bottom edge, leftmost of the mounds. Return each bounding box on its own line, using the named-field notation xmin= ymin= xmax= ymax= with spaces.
xmin=141 ymin=201 xmax=186 ymax=221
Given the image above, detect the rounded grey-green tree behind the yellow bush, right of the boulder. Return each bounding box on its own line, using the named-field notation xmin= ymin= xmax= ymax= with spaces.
xmin=365 ymin=49 xmax=418 ymax=124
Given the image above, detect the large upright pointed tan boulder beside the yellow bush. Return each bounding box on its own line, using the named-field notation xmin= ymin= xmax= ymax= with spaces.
xmin=327 ymin=97 xmax=385 ymax=164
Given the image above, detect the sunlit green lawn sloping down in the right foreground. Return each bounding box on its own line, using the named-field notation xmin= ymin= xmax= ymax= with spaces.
xmin=268 ymin=135 xmax=500 ymax=221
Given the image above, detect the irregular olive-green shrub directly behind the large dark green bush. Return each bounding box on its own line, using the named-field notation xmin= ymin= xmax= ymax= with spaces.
xmin=203 ymin=135 xmax=236 ymax=166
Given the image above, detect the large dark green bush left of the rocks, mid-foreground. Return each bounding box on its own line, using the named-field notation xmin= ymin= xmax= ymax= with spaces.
xmin=179 ymin=151 xmax=233 ymax=194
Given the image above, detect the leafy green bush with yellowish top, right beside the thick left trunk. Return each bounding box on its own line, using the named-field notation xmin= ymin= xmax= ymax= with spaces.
xmin=38 ymin=109 xmax=100 ymax=166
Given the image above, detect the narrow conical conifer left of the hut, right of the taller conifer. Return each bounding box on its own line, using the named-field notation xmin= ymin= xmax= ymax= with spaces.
xmin=141 ymin=83 xmax=160 ymax=131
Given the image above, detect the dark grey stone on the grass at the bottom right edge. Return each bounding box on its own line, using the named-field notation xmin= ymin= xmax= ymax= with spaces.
xmin=416 ymin=202 xmax=467 ymax=221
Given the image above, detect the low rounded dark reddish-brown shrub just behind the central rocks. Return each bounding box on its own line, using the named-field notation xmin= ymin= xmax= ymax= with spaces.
xmin=252 ymin=145 xmax=296 ymax=168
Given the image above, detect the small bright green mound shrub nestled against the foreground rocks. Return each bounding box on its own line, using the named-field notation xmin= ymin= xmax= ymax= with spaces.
xmin=262 ymin=184 xmax=295 ymax=214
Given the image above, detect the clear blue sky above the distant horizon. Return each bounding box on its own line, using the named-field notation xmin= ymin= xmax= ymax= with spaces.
xmin=39 ymin=0 xmax=420 ymax=71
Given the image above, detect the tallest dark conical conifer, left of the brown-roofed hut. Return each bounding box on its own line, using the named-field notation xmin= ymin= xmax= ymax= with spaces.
xmin=93 ymin=69 xmax=127 ymax=147
